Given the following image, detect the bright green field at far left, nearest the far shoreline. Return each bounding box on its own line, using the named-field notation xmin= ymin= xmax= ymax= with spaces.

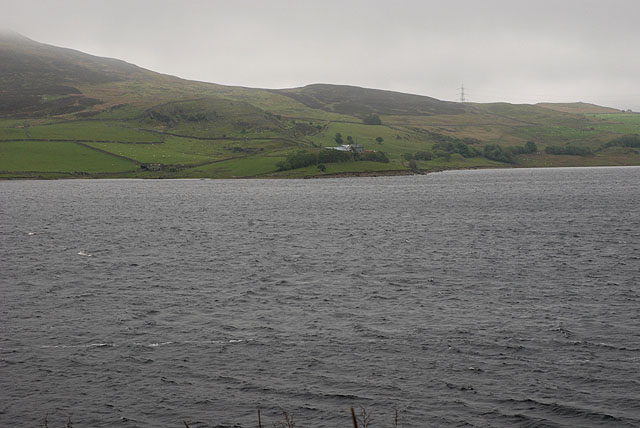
xmin=0 ymin=141 xmax=138 ymax=173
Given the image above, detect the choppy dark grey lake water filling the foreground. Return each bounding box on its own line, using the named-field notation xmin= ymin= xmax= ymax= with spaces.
xmin=0 ymin=168 xmax=640 ymax=428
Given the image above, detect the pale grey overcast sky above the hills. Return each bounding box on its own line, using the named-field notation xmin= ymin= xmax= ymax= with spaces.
xmin=0 ymin=0 xmax=640 ymax=111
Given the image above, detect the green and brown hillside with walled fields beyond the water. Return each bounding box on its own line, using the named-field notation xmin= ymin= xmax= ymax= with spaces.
xmin=0 ymin=34 xmax=640 ymax=178
